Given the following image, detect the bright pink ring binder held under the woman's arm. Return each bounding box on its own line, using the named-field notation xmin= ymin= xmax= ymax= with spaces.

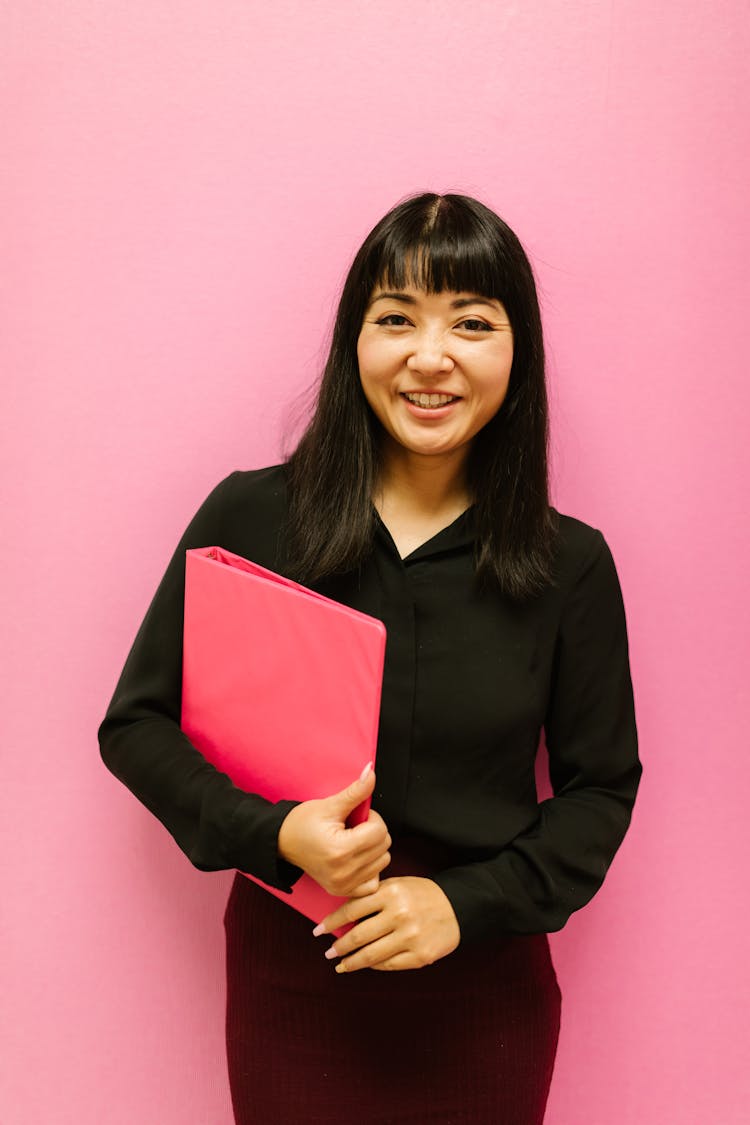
xmin=182 ymin=547 xmax=386 ymax=921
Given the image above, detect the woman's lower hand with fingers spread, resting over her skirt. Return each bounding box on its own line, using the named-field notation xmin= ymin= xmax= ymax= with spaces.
xmin=314 ymin=875 xmax=461 ymax=973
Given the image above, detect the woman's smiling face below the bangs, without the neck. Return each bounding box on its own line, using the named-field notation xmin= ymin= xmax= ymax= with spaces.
xmin=356 ymin=288 xmax=513 ymax=457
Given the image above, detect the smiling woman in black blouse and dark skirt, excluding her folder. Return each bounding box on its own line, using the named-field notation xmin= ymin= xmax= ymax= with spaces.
xmin=100 ymin=195 xmax=640 ymax=1125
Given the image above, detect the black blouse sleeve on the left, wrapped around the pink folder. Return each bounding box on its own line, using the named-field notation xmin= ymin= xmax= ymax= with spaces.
xmin=99 ymin=474 xmax=300 ymax=890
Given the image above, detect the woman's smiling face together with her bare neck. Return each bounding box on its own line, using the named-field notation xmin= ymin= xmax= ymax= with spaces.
xmin=356 ymin=288 xmax=513 ymax=554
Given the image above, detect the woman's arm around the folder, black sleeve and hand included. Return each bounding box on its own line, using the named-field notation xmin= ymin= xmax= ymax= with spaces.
xmin=99 ymin=474 xmax=390 ymax=894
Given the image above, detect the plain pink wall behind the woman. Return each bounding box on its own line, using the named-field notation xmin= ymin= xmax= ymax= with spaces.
xmin=0 ymin=0 xmax=750 ymax=1125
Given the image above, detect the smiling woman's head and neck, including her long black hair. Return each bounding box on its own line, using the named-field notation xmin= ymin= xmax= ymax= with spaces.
xmin=290 ymin=195 xmax=555 ymax=599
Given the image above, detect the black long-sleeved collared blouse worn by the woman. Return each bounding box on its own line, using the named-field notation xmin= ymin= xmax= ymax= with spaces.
xmin=99 ymin=466 xmax=641 ymax=942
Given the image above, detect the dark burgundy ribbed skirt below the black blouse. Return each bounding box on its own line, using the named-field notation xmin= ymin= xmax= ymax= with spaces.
xmin=225 ymin=875 xmax=560 ymax=1125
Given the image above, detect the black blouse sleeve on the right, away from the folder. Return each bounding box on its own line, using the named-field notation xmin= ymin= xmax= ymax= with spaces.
xmin=434 ymin=532 xmax=641 ymax=941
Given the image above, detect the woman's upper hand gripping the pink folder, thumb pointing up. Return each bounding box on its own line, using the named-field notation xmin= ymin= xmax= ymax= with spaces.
xmin=279 ymin=767 xmax=391 ymax=898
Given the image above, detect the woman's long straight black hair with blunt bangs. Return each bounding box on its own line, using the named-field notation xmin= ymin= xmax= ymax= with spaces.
xmin=288 ymin=194 xmax=557 ymax=601
